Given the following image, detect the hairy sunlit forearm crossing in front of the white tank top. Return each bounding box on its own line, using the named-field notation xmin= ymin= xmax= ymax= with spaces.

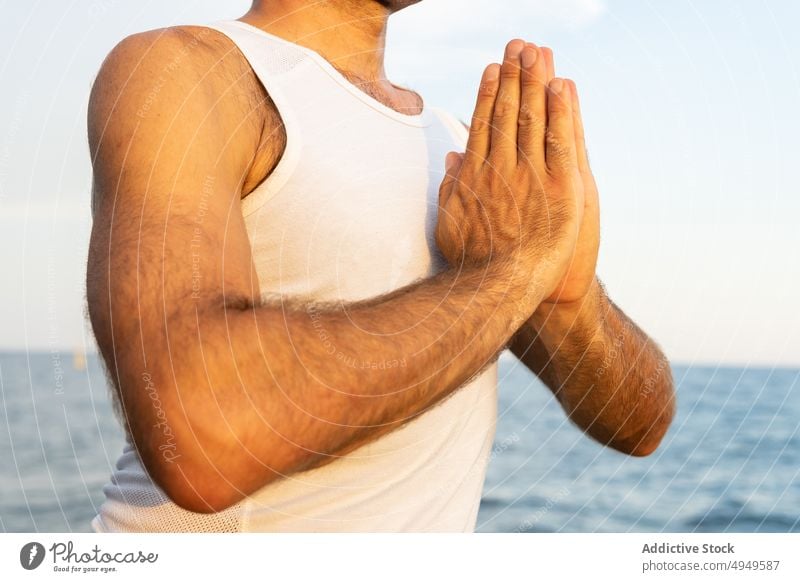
xmin=134 ymin=260 xmax=535 ymax=509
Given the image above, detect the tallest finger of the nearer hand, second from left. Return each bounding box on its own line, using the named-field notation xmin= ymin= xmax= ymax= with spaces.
xmin=490 ymin=39 xmax=525 ymax=166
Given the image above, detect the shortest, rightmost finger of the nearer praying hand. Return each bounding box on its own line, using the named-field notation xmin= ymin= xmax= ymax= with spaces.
xmin=545 ymin=77 xmax=577 ymax=175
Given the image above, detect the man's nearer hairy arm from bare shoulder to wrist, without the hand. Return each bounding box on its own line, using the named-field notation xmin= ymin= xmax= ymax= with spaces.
xmin=87 ymin=30 xmax=552 ymax=512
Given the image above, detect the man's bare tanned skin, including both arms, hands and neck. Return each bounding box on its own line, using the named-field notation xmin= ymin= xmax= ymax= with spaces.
xmin=87 ymin=0 xmax=673 ymax=512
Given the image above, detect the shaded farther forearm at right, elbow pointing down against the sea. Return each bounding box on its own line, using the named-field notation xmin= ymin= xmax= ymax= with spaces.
xmin=512 ymin=280 xmax=674 ymax=455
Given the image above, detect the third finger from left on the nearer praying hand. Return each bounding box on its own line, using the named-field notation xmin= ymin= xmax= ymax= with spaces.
xmin=518 ymin=45 xmax=547 ymax=171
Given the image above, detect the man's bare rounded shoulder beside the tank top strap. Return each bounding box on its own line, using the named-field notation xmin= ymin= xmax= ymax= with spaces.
xmin=88 ymin=26 xmax=283 ymax=196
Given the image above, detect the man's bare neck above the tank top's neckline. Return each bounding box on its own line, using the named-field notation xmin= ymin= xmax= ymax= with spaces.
xmin=245 ymin=0 xmax=389 ymax=82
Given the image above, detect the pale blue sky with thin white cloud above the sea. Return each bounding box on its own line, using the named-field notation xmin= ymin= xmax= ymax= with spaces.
xmin=0 ymin=0 xmax=800 ymax=366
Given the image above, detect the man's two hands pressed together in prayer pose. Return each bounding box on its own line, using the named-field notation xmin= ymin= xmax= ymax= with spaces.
xmin=437 ymin=40 xmax=599 ymax=302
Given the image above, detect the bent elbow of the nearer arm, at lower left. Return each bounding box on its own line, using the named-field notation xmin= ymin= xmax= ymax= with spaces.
xmin=122 ymin=354 xmax=310 ymax=513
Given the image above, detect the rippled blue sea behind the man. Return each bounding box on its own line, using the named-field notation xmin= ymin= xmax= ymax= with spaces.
xmin=0 ymin=351 xmax=800 ymax=533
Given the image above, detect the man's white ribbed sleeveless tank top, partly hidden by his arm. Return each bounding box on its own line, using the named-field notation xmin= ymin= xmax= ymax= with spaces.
xmin=92 ymin=21 xmax=497 ymax=532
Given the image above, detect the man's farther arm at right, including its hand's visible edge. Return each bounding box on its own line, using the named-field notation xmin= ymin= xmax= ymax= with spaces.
xmin=510 ymin=47 xmax=675 ymax=456
